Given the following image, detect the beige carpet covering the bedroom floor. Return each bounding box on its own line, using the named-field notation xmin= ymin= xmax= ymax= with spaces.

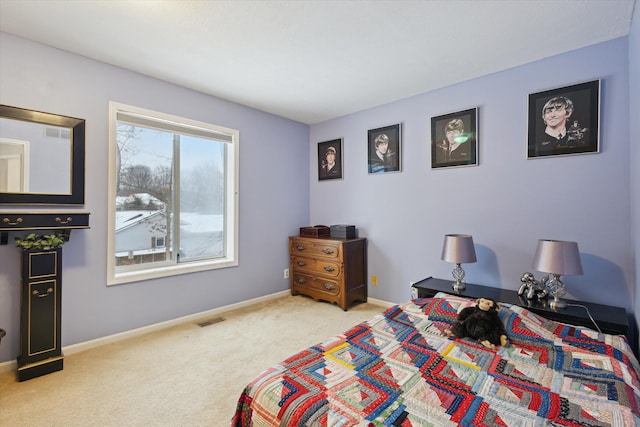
xmin=0 ymin=296 xmax=385 ymax=427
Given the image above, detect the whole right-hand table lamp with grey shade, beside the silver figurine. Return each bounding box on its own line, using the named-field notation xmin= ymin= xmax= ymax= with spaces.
xmin=532 ymin=239 xmax=582 ymax=310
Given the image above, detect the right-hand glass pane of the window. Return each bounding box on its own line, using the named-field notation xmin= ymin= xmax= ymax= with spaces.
xmin=180 ymin=135 xmax=225 ymax=262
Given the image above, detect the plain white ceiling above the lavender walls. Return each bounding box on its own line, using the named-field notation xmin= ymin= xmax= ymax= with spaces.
xmin=0 ymin=0 xmax=635 ymax=124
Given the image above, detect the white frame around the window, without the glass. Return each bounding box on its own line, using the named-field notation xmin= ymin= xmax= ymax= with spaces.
xmin=107 ymin=101 xmax=240 ymax=286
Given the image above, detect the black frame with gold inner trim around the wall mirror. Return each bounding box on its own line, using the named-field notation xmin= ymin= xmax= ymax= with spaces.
xmin=0 ymin=105 xmax=85 ymax=205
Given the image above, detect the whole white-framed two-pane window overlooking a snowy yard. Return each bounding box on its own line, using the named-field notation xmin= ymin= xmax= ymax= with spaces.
xmin=107 ymin=102 xmax=239 ymax=285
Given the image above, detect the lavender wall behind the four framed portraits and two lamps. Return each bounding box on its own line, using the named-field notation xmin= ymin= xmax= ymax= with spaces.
xmin=310 ymin=38 xmax=637 ymax=320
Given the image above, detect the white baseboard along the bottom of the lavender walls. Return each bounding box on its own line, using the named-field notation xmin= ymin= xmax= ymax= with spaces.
xmin=0 ymin=289 xmax=395 ymax=373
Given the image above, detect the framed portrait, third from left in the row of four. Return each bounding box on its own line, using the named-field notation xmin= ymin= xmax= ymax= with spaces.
xmin=431 ymin=107 xmax=478 ymax=169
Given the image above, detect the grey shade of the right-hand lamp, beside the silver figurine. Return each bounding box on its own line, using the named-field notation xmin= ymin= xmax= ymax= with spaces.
xmin=532 ymin=240 xmax=582 ymax=275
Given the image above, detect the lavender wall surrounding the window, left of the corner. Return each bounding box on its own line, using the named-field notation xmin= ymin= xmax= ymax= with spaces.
xmin=0 ymin=34 xmax=309 ymax=362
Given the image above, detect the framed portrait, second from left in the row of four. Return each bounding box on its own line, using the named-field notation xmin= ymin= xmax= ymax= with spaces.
xmin=368 ymin=123 xmax=402 ymax=173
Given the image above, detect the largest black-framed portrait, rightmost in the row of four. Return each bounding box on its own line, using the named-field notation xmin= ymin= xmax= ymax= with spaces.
xmin=527 ymin=80 xmax=600 ymax=159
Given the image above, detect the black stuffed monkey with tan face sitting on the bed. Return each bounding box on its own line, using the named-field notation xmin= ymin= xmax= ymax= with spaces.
xmin=445 ymin=298 xmax=507 ymax=349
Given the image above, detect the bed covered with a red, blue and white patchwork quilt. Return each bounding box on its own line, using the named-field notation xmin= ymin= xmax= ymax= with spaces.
xmin=232 ymin=294 xmax=640 ymax=427
